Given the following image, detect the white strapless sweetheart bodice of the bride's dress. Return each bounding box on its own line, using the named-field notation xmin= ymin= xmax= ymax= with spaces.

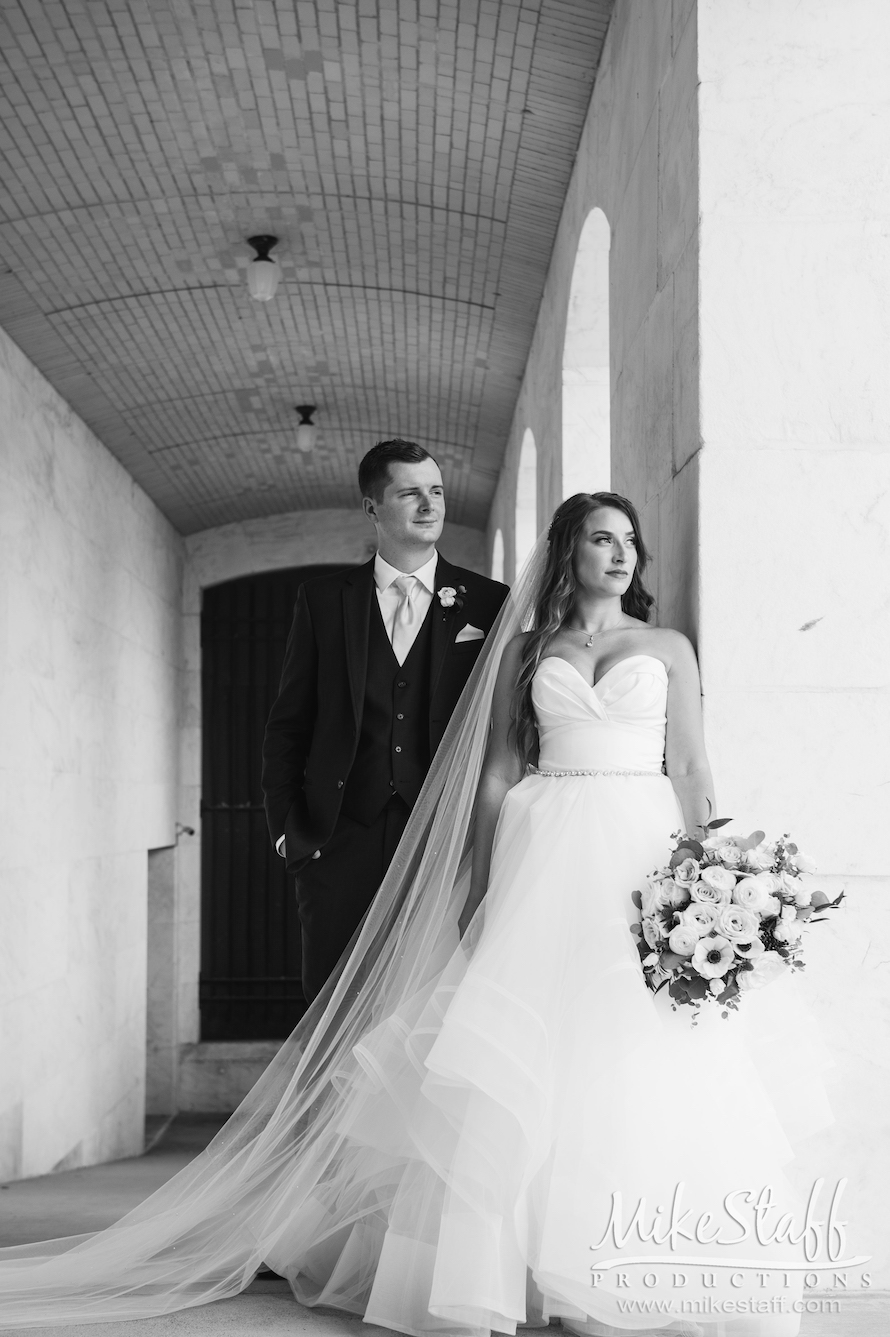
xmin=532 ymin=655 xmax=668 ymax=771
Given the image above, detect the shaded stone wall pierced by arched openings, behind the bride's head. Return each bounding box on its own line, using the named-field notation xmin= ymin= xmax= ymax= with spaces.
xmin=488 ymin=0 xmax=699 ymax=632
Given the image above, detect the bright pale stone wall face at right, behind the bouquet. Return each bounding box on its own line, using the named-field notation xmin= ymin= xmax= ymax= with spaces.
xmin=699 ymin=0 xmax=890 ymax=1288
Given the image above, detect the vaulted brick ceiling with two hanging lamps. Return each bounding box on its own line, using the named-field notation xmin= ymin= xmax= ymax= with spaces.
xmin=0 ymin=0 xmax=612 ymax=533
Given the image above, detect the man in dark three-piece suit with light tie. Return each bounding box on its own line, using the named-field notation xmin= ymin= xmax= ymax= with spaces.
xmin=263 ymin=440 xmax=506 ymax=1001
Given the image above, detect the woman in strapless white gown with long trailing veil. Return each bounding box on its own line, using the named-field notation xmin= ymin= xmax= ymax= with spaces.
xmin=0 ymin=492 xmax=829 ymax=1337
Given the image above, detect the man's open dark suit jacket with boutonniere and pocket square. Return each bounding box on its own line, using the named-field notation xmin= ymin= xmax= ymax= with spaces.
xmin=263 ymin=554 xmax=508 ymax=870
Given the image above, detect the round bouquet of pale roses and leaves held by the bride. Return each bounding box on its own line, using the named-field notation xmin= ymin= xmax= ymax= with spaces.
xmin=632 ymin=817 xmax=843 ymax=1024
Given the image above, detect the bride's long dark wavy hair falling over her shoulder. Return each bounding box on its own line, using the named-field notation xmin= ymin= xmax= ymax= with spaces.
xmin=512 ymin=492 xmax=655 ymax=766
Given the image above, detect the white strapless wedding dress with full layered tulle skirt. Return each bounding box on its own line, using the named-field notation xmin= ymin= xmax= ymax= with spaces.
xmin=262 ymin=655 xmax=830 ymax=1337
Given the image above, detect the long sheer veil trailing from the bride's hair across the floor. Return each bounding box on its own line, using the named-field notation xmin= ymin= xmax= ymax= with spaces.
xmin=0 ymin=539 xmax=547 ymax=1328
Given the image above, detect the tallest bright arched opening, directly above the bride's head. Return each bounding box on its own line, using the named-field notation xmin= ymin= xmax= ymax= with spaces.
xmin=563 ymin=209 xmax=612 ymax=497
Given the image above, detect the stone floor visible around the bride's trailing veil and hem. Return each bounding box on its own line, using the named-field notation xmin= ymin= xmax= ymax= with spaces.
xmin=0 ymin=1115 xmax=890 ymax=1337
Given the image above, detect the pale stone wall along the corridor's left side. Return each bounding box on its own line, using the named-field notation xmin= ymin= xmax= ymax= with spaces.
xmin=0 ymin=333 xmax=183 ymax=1178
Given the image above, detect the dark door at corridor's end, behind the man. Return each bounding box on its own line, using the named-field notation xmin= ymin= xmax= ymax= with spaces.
xmin=200 ymin=566 xmax=342 ymax=1040
